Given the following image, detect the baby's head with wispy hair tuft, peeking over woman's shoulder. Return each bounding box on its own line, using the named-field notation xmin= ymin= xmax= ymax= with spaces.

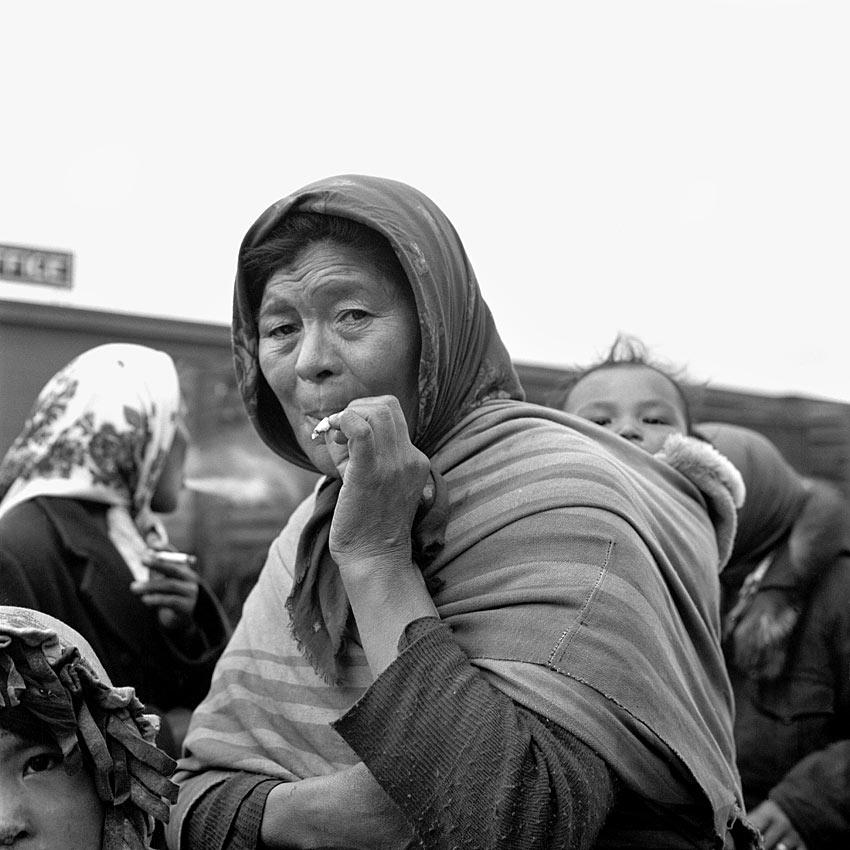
xmin=559 ymin=335 xmax=692 ymax=454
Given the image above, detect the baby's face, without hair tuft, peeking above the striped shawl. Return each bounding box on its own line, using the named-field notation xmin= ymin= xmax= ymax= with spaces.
xmin=564 ymin=364 xmax=688 ymax=454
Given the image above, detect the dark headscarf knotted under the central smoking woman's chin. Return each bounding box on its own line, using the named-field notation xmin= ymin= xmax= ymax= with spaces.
xmin=233 ymin=175 xmax=523 ymax=679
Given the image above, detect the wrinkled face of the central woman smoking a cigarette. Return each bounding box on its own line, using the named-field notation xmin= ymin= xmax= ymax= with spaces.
xmin=257 ymin=241 xmax=420 ymax=475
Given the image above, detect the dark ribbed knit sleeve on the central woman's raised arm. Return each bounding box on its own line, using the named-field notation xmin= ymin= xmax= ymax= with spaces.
xmin=333 ymin=618 xmax=615 ymax=850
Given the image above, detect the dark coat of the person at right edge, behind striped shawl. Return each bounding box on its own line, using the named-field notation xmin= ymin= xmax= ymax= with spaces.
xmin=730 ymin=555 xmax=850 ymax=850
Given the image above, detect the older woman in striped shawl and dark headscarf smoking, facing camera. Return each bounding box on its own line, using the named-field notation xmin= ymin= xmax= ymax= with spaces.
xmin=169 ymin=176 xmax=750 ymax=850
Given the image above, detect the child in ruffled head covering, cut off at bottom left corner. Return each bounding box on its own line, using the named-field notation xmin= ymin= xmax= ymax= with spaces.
xmin=0 ymin=605 xmax=177 ymax=850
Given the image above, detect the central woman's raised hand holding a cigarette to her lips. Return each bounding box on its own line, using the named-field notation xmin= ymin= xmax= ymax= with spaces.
xmin=320 ymin=396 xmax=431 ymax=568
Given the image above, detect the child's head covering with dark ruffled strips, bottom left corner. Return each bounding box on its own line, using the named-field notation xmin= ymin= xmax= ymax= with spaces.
xmin=0 ymin=606 xmax=177 ymax=850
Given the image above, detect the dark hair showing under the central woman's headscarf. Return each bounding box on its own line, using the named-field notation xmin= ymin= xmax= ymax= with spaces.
xmin=241 ymin=212 xmax=409 ymax=315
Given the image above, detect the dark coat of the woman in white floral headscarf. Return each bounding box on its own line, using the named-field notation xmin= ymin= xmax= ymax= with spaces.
xmin=0 ymin=496 xmax=229 ymax=712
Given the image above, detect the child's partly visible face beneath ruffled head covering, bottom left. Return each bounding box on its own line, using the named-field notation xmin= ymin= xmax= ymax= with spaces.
xmin=0 ymin=728 xmax=104 ymax=850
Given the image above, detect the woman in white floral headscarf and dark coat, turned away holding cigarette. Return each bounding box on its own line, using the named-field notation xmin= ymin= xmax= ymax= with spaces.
xmin=0 ymin=343 xmax=229 ymax=755
